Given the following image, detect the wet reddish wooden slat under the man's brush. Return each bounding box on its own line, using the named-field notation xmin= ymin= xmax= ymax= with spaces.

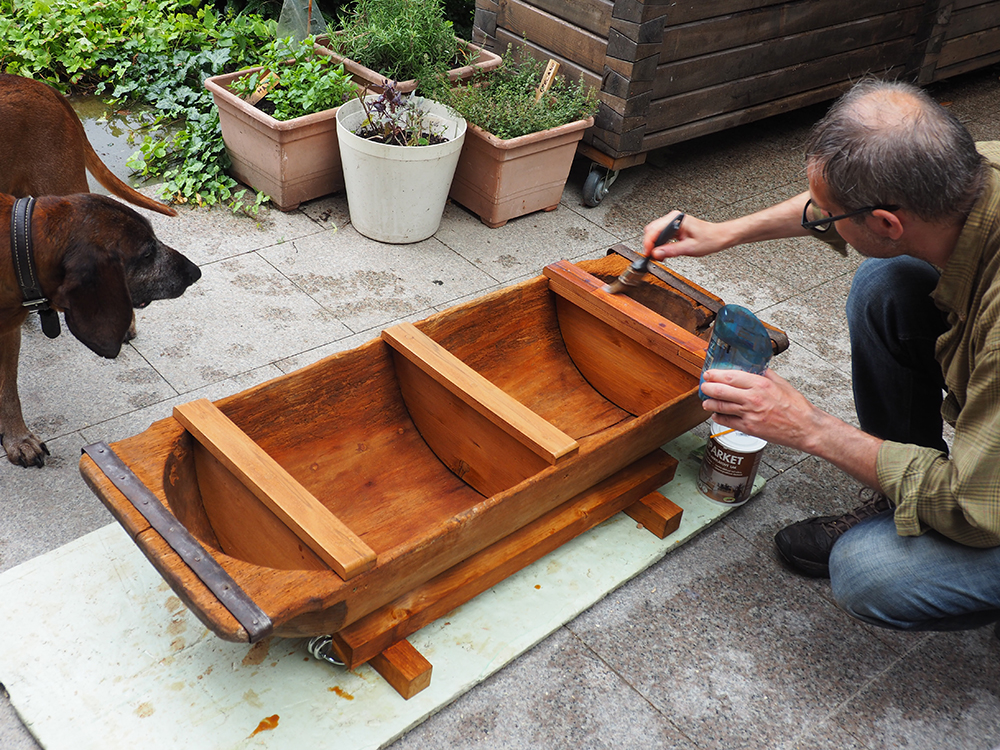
xmin=543 ymin=261 xmax=708 ymax=375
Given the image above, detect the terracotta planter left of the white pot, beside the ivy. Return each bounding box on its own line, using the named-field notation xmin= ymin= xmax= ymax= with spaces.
xmin=205 ymin=68 xmax=354 ymax=211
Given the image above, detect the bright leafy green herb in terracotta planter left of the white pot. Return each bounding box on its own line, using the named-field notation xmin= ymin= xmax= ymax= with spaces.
xmin=230 ymin=37 xmax=357 ymax=120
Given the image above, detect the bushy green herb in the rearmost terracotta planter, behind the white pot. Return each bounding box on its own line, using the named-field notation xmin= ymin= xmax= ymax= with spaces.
xmin=331 ymin=0 xmax=459 ymax=82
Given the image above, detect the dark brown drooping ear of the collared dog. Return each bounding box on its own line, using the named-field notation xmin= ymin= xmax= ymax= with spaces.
xmin=52 ymin=245 xmax=132 ymax=359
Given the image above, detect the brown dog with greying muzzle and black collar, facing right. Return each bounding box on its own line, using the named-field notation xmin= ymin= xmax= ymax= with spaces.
xmin=0 ymin=194 xmax=201 ymax=466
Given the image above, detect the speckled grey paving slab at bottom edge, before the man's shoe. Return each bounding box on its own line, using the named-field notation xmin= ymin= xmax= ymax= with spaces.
xmin=567 ymin=532 xmax=897 ymax=750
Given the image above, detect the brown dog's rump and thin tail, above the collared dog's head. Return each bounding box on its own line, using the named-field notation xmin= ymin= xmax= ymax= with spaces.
xmin=0 ymin=74 xmax=176 ymax=216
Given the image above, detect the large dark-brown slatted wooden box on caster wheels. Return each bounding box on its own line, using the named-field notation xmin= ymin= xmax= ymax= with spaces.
xmin=473 ymin=0 xmax=1000 ymax=205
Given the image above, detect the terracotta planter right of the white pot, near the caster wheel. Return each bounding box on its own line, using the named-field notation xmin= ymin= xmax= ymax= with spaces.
xmin=450 ymin=117 xmax=594 ymax=228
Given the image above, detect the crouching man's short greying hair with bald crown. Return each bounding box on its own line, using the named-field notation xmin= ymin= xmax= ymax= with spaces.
xmin=806 ymin=78 xmax=986 ymax=221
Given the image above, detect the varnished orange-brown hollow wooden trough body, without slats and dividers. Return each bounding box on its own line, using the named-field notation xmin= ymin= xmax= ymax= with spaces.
xmin=81 ymin=260 xmax=720 ymax=641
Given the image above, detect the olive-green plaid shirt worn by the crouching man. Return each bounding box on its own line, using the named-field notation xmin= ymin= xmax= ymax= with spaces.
xmin=876 ymin=141 xmax=1000 ymax=547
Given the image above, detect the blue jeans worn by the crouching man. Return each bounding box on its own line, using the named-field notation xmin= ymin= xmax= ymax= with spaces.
xmin=830 ymin=256 xmax=1000 ymax=630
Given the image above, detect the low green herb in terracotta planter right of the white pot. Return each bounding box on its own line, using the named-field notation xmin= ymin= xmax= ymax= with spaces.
xmin=435 ymin=46 xmax=598 ymax=140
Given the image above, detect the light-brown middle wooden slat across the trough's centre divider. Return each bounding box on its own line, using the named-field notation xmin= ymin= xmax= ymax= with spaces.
xmin=382 ymin=323 xmax=579 ymax=464
